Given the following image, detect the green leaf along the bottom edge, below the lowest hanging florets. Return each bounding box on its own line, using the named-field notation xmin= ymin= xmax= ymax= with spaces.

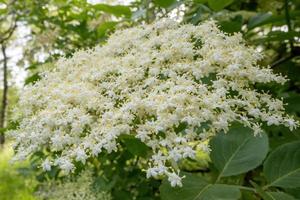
xmin=160 ymin=174 xmax=241 ymax=200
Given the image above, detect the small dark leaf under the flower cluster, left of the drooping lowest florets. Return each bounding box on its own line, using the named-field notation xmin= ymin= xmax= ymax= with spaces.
xmin=122 ymin=135 xmax=149 ymax=157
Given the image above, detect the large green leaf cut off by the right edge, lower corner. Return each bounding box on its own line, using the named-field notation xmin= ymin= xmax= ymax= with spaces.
xmin=263 ymin=141 xmax=300 ymax=188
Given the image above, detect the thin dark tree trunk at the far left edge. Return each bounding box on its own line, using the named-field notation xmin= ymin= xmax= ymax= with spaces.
xmin=0 ymin=43 xmax=8 ymax=145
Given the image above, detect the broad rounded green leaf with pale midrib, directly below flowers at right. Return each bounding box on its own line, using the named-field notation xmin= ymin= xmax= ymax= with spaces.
xmin=210 ymin=126 xmax=269 ymax=177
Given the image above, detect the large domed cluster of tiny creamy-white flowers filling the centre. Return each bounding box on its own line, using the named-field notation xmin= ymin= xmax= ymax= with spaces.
xmin=10 ymin=19 xmax=298 ymax=186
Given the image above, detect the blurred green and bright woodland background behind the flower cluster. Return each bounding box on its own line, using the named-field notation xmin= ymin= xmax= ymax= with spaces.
xmin=0 ymin=0 xmax=300 ymax=200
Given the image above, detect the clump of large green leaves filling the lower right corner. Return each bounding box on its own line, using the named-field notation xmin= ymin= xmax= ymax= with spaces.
xmin=160 ymin=127 xmax=300 ymax=200
